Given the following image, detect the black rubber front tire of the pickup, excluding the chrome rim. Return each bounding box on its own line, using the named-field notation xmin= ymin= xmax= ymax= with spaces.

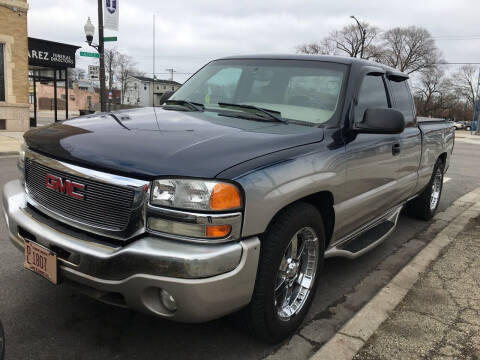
xmin=244 ymin=203 xmax=325 ymax=343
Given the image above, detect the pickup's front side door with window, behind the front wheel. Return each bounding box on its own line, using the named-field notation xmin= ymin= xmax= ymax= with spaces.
xmin=337 ymin=72 xmax=400 ymax=238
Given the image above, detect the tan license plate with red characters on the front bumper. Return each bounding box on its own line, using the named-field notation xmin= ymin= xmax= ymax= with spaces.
xmin=23 ymin=240 xmax=57 ymax=284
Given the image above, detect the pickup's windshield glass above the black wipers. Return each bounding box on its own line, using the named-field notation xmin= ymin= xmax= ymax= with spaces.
xmin=170 ymin=59 xmax=347 ymax=125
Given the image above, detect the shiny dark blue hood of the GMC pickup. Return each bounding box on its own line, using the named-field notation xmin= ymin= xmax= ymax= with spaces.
xmin=25 ymin=108 xmax=323 ymax=179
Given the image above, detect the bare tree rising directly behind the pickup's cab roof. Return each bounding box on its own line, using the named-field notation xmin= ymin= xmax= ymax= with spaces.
xmin=297 ymin=22 xmax=381 ymax=59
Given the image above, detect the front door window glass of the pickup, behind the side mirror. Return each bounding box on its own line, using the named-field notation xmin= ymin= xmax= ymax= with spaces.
xmin=355 ymin=75 xmax=388 ymax=121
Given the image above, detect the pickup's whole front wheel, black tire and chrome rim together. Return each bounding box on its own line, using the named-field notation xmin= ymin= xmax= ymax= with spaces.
xmin=245 ymin=203 xmax=325 ymax=343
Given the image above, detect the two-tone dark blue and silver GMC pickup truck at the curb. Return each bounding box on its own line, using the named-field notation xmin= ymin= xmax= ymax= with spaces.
xmin=3 ymin=55 xmax=455 ymax=342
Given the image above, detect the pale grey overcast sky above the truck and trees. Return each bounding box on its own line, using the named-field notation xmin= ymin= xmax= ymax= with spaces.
xmin=28 ymin=0 xmax=480 ymax=81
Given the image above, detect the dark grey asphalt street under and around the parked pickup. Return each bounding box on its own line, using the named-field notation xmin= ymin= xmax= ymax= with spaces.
xmin=0 ymin=141 xmax=480 ymax=360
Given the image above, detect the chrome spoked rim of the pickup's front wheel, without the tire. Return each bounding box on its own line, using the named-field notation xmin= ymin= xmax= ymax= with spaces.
xmin=274 ymin=227 xmax=319 ymax=321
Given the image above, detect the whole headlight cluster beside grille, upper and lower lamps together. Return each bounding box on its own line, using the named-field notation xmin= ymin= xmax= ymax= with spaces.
xmin=147 ymin=179 xmax=242 ymax=242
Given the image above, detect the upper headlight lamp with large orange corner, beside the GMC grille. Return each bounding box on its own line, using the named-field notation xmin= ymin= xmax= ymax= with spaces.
xmin=151 ymin=179 xmax=242 ymax=211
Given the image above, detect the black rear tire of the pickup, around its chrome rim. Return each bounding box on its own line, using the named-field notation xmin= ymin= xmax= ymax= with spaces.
xmin=406 ymin=159 xmax=444 ymax=220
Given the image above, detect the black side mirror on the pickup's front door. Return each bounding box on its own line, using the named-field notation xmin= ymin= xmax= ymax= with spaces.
xmin=354 ymin=108 xmax=405 ymax=134
